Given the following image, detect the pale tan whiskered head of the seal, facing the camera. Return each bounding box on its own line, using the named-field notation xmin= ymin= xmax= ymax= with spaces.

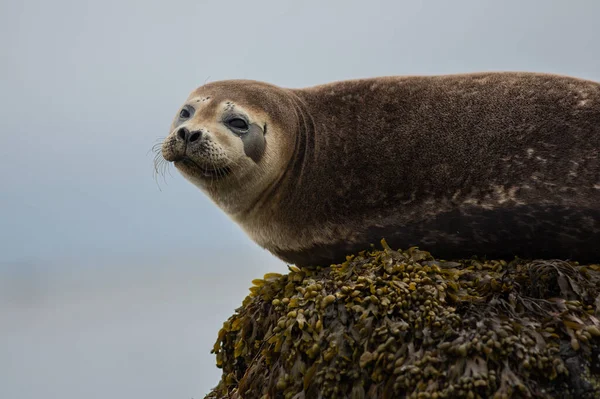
xmin=162 ymin=80 xmax=295 ymax=214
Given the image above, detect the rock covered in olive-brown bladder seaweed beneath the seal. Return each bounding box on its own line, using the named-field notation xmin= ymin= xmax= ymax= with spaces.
xmin=207 ymin=241 xmax=600 ymax=399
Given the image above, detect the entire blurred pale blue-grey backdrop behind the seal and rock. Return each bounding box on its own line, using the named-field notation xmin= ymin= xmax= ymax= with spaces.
xmin=0 ymin=0 xmax=600 ymax=399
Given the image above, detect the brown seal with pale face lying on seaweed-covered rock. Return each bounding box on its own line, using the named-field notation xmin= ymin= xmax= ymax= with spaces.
xmin=161 ymin=72 xmax=600 ymax=266
